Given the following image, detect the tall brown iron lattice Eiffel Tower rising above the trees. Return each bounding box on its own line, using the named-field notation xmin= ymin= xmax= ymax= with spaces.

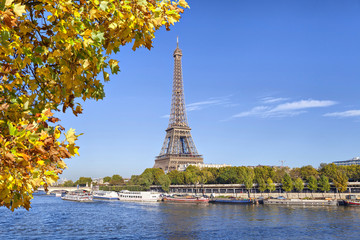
xmin=154 ymin=39 xmax=203 ymax=172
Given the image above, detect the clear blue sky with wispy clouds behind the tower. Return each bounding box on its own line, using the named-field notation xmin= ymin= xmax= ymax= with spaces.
xmin=61 ymin=0 xmax=360 ymax=180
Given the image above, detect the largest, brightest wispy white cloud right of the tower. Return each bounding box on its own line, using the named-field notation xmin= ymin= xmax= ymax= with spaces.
xmin=232 ymin=99 xmax=336 ymax=118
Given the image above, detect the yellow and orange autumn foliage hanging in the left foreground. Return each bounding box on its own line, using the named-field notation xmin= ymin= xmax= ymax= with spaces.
xmin=0 ymin=0 xmax=188 ymax=210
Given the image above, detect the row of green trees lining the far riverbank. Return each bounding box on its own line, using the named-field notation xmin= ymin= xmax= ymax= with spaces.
xmin=63 ymin=164 xmax=360 ymax=192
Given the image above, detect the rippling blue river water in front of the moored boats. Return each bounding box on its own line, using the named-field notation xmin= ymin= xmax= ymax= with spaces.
xmin=0 ymin=196 xmax=360 ymax=240
